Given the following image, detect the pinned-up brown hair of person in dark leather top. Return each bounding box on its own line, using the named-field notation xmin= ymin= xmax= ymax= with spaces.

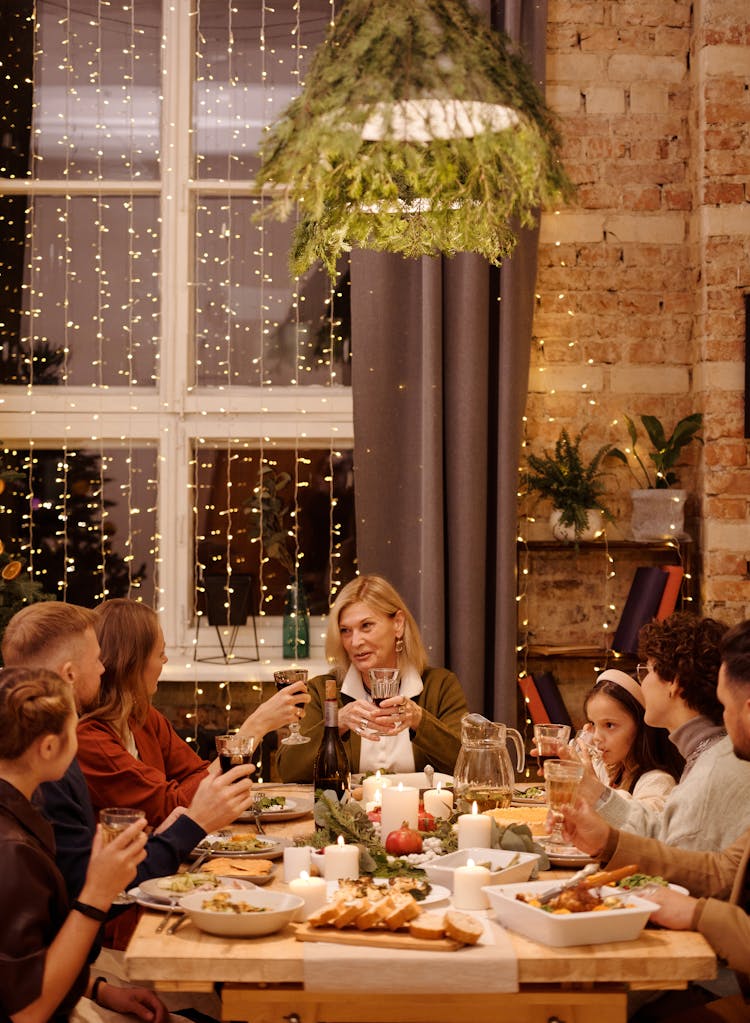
xmin=0 ymin=668 xmax=76 ymax=760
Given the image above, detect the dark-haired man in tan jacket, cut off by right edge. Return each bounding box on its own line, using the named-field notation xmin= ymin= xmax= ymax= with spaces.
xmin=563 ymin=620 xmax=750 ymax=1021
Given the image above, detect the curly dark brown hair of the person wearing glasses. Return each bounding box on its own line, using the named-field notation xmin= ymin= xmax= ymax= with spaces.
xmin=638 ymin=611 xmax=729 ymax=724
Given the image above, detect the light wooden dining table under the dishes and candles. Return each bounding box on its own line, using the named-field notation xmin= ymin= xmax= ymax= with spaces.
xmin=125 ymin=786 xmax=716 ymax=1023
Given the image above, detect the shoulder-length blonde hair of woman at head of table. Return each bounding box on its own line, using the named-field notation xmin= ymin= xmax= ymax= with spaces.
xmin=325 ymin=575 xmax=428 ymax=674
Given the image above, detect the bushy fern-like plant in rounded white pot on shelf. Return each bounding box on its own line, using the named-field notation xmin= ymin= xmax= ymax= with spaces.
xmin=526 ymin=430 xmax=614 ymax=541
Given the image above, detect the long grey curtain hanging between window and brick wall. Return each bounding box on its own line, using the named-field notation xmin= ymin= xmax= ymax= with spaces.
xmin=351 ymin=0 xmax=546 ymax=724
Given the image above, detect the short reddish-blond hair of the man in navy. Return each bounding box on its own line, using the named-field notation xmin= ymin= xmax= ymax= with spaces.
xmin=2 ymin=601 xmax=96 ymax=669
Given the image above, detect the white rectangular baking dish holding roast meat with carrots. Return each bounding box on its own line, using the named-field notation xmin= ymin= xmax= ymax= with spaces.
xmin=482 ymin=881 xmax=658 ymax=948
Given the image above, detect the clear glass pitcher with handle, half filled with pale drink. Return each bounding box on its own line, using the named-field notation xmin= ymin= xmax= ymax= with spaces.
xmin=453 ymin=714 xmax=526 ymax=813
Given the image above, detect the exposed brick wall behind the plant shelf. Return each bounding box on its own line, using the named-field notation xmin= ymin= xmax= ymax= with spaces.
xmin=522 ymin=0 xmax=750 ymax=671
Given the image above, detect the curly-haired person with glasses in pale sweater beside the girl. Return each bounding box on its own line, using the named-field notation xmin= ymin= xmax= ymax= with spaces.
xmin=595 ymin=612 xmax=750 ymax=850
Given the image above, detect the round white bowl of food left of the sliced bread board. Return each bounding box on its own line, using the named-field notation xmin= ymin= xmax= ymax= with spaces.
xmin=180 ymin=888 xmax=305 ymax=938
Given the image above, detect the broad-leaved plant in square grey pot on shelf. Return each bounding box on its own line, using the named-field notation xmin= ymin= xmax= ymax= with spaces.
xmin=609 ymin=412 xmax=703 ymax=540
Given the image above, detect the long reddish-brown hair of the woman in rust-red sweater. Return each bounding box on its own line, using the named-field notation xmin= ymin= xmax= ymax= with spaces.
xmin=86 ymin=597 xmax=159 ymax=736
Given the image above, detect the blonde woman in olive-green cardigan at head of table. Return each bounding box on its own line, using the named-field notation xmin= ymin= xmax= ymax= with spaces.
xmin=278 ymin=575 xmax=469 ymax=782
